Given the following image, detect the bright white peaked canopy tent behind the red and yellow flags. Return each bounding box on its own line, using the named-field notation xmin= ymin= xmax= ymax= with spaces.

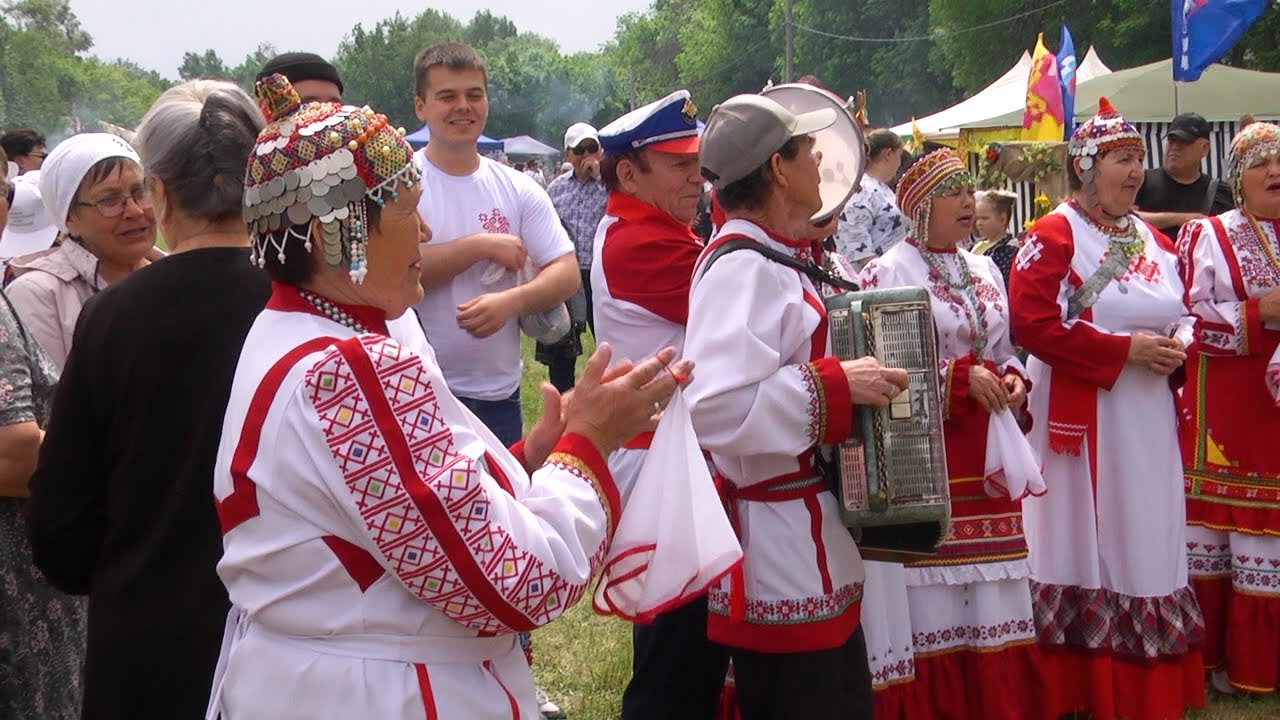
xmin=892 ymin=47 xmax=1111 ymax=142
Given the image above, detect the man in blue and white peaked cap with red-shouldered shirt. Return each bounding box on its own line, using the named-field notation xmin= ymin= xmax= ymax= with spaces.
xmin=591 ymin=90 xmax=728 ymax=720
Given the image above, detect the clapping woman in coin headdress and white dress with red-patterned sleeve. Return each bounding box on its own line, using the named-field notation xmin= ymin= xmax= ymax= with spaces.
xmin=210 ymin=76 xmax=690 ymax=720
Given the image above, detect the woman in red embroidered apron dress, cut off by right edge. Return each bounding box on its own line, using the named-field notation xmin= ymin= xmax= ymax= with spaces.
xmin=1178 ymin=123 xmax=1280 ymax=693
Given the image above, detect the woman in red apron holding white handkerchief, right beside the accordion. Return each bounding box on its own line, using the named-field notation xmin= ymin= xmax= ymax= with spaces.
xmin=859 ymin=150 xmax=1044 ymax=720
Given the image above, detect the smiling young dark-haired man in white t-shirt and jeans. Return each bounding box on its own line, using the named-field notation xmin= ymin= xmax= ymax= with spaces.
xmin=413 ymin=42 xmax=581 ymax=445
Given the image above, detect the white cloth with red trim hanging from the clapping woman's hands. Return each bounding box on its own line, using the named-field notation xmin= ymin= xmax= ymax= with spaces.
xmin=591 ymin=389 xmax=742 ymax=623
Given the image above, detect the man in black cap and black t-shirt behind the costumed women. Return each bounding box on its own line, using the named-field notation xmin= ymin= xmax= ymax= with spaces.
xmin=1134 ymin=113 xmax=1235 ymax=241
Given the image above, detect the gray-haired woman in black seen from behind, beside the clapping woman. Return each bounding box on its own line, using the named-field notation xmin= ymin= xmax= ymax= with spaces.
xmin=28 ymin=81 xmax=269 ymax=717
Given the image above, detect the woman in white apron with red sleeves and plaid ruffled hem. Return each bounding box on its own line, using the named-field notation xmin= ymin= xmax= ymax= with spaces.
xmin=1010 ymin=99 xmax=1203 ymax=720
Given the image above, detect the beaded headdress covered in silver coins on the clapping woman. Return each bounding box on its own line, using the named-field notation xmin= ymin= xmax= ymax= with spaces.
xmin=244 ymin=74 xmax=421 ymax=283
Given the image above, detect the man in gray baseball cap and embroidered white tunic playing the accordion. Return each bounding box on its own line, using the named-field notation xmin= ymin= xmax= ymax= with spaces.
xmin=685 ymin=95 xmax=908 ymax=720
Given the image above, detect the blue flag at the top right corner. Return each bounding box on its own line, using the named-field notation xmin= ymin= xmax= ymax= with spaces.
xmin=1171 ymin=0 xmax=1267 ymax=82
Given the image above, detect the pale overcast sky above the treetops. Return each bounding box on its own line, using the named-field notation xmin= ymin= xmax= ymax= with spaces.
xmin=70 ymin=0 xmax=650 ymax=79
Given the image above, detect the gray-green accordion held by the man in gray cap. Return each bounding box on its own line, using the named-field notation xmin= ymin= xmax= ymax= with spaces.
xmin=822 ymin=287 xmax=951 ymax=562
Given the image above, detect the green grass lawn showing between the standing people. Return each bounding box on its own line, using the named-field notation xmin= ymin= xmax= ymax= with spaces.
xmin=521 ymin=333 xmax=1280 ymax=720
